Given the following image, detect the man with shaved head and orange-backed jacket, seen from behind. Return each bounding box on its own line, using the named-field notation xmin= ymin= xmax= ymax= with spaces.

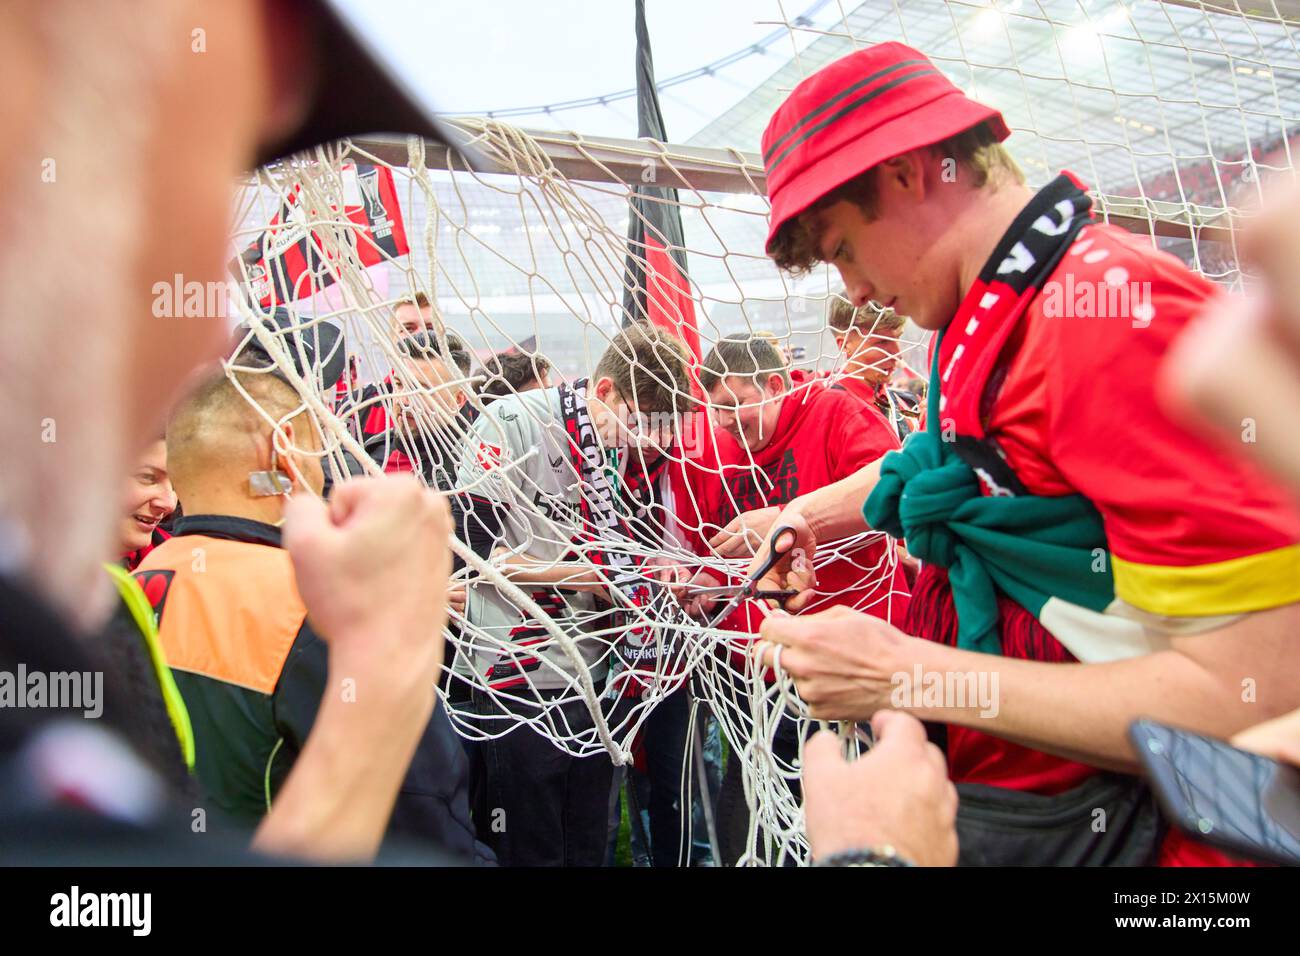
xmin=135 ymin=356 xmax=486 ymax=858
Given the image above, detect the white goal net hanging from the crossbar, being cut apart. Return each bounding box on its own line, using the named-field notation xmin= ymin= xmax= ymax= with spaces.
xmin=230 ymin=0 xmax=1300 ymax=864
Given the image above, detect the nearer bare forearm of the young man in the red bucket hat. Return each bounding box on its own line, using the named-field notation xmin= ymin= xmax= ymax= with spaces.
xmin=901 ymin=624 xmax=1300 ymax=771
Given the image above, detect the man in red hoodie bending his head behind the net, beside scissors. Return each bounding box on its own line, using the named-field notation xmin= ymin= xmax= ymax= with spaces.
xmin=699 ymin=334 xmax=907 ymax=864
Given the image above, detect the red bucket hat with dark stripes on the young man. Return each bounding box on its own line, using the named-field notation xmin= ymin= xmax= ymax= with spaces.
xmin=763 ymin=43 xmax=1011 ymax=247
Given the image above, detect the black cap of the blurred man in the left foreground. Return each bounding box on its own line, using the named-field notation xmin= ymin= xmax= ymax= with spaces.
xmin=257 ymin=0 xmax=493 ymax=169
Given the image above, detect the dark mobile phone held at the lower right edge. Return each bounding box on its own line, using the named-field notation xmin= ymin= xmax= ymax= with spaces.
xmin=1128 ymin=719 xmax=1300 ymax=866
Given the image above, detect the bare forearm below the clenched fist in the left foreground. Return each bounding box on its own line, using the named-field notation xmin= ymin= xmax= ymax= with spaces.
xmin=254 ymin=666 xmax=434 ymax=862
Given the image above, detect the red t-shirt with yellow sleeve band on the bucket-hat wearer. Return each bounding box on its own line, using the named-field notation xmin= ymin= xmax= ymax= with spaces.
xmin=917 ymin=225 xmax=1300 ymax=864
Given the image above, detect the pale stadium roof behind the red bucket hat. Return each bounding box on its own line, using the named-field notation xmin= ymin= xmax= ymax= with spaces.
xmin=689 ymin=0 xmax=1300 ymax=206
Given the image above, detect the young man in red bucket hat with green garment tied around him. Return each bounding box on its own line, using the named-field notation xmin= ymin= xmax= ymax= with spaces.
xmin=733 ymin=43 xmax=1300 ymax=864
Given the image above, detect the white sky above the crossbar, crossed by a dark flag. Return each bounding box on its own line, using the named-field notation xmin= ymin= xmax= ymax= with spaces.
xmin=345 ymin=0 xmax=855 ymax=142
